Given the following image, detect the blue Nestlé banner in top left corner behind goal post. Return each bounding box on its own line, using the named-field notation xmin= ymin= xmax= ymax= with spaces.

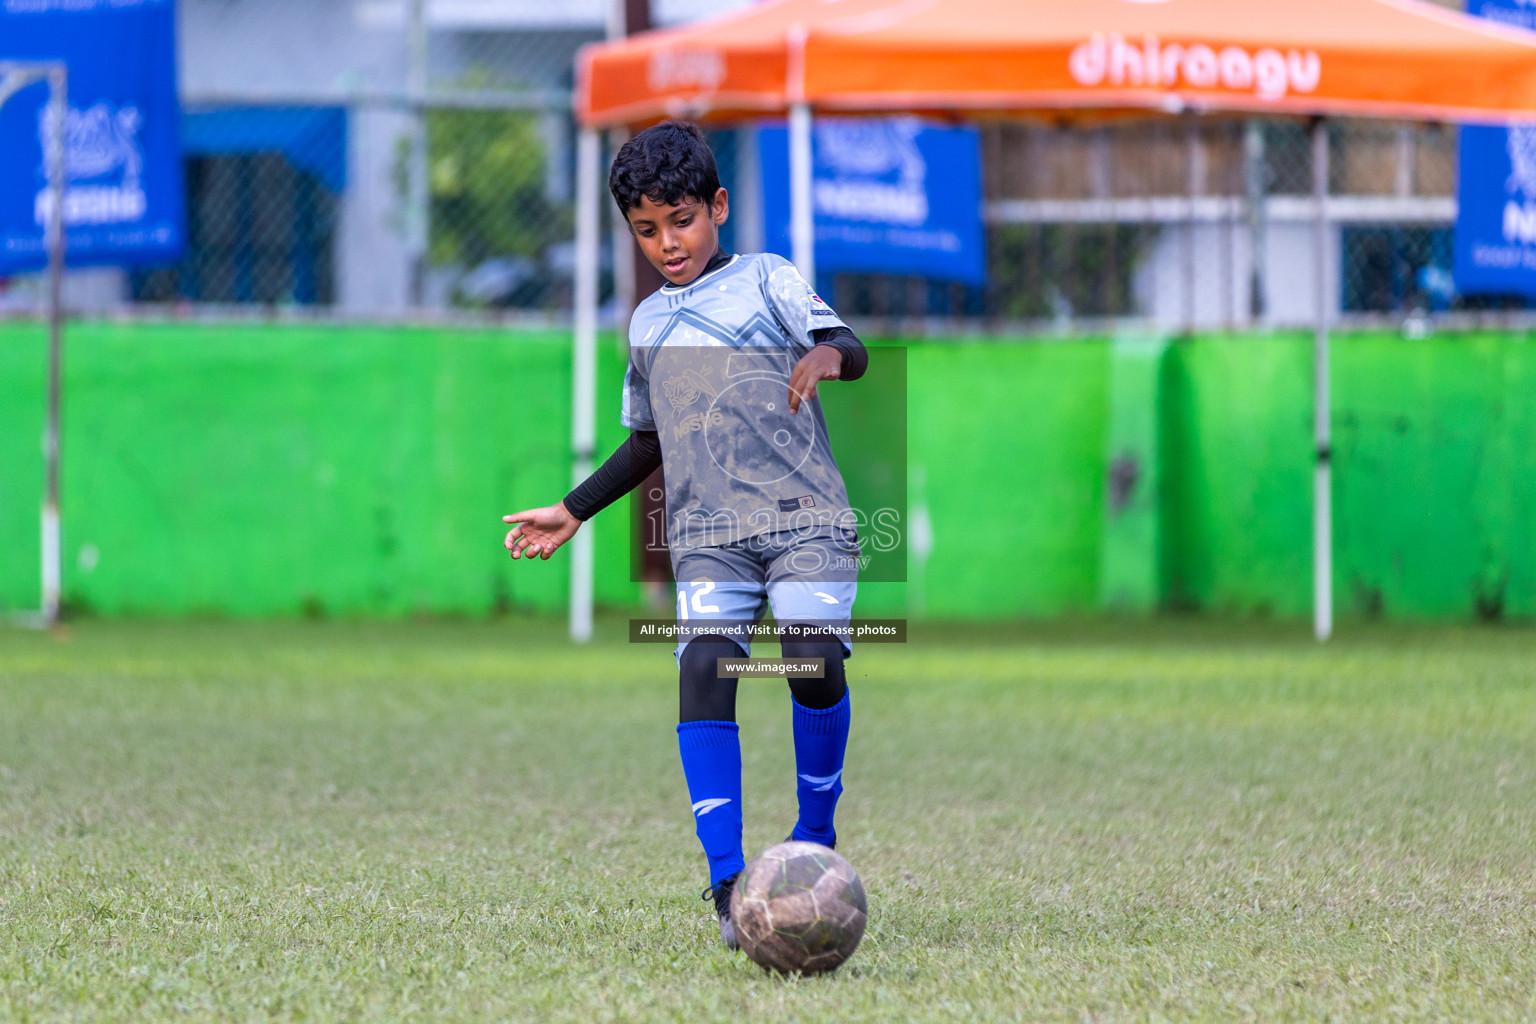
xmin=0 ymin=0 xmax=183 ymax=273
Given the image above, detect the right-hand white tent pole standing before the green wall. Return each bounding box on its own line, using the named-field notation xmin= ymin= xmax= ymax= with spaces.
xmin=1312 ymin=117 xmax=1333 ymax=640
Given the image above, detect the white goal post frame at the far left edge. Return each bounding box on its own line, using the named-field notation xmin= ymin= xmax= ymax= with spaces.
xmin=0 ymin=61 xmax=69 ymax=626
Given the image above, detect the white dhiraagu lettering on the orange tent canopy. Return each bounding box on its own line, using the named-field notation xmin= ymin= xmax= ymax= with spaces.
xmin=1068 ymin=32 xmax=1322 ymax=100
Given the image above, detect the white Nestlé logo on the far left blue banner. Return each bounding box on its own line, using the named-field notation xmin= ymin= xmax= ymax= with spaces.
xmin=32 ymin=103 xmax=149 ymax=226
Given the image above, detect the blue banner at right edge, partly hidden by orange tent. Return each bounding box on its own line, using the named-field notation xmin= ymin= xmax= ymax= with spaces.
xmin=1455 ymin=0 xmax=1536 ymax=296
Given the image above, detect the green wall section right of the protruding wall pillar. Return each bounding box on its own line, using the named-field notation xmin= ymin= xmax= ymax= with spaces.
xmin=1161 ymin=335 xmax=1536 ymax=619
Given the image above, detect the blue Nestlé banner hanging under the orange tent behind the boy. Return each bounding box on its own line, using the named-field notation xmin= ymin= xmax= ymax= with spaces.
xmin=757 ymin=117 xmax=986 ymax=284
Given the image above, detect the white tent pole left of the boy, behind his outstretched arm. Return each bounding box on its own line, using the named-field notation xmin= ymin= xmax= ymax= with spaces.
xmin=570 ymin=127 xmax=602 ymax=643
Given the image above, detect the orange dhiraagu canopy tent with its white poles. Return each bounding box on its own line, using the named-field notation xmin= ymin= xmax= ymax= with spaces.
xmin=559 ymin=0 xmax=1536 ymax=639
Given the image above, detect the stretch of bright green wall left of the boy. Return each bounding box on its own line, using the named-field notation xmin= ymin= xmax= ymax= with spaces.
xmin=0 ymin=324 xmax=634 ymax=614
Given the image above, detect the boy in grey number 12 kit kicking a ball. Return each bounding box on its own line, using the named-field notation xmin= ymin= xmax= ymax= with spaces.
xmin=504 ymin=121 xmax=868 ymax=949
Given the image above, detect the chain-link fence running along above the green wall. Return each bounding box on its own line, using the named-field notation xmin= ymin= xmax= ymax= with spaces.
xmin=0 ymin=0 xmax=1524 ymax=332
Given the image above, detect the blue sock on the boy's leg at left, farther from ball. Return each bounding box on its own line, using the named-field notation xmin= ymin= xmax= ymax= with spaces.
xmin=677 ymin=722 xmax=746 ymax=884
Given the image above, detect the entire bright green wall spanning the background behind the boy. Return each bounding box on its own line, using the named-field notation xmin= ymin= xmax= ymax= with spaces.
xmin=0 ymin=324 xmax=1536 ymax=619
